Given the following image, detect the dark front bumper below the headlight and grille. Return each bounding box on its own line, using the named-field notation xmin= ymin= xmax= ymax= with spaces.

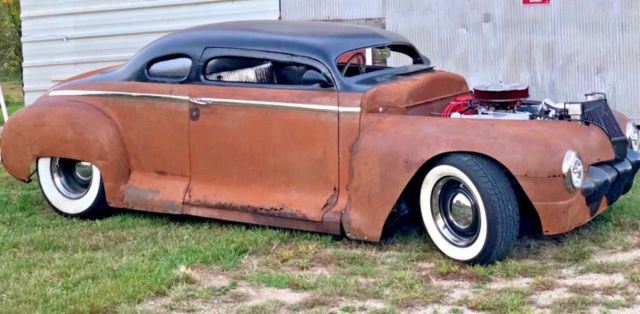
xmin=582 ymin=149 xmax=640 ymax=217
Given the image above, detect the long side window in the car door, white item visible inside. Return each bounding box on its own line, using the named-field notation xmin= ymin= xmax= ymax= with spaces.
xmin=204 ymin=57 xmax=332 ymax=88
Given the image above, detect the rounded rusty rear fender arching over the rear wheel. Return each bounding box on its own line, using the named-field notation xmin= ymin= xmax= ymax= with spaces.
xmin=0 ymin=96 xmax=129 ymax=206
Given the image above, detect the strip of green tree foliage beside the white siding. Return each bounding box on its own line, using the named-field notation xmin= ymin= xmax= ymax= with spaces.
xmin=0 ymin=0 xmax=22 ymax=79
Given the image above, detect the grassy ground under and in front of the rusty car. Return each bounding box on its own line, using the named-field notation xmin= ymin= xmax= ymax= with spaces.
xmin=0 ymin=163 xmax=640 ymax=313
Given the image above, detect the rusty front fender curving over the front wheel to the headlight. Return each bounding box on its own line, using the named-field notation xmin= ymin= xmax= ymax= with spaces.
xmin=343 ymin=114 xmax=614 ymax=241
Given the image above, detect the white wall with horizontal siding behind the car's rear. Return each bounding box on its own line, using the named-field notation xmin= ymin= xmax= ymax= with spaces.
xmin=21 ymin=0 xmax=280 ymax=103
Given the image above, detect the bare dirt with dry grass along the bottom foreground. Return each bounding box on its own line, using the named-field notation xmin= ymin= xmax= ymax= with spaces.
xmin=136 ymin=250 xmax=640 ymax=313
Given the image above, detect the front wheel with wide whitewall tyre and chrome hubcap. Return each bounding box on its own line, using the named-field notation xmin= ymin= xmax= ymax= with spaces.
xmin=420 ymin=154 xmax=520 ymax=264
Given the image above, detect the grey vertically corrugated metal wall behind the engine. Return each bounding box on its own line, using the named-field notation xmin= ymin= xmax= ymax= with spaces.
xmin=282 ymin=0 xmax=640 ymax=122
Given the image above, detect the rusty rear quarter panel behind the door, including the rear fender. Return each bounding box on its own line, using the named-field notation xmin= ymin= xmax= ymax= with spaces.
xmin=1 ymin=82 xmax=189 ymax=213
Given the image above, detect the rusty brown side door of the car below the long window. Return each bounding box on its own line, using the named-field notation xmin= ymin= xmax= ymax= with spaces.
xmin=185 ymin=85 xmax=339 ymax=222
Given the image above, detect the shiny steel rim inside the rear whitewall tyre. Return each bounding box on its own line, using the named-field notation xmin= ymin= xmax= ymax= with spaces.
xmin=51 ymin=158 xmax=93 ymax=199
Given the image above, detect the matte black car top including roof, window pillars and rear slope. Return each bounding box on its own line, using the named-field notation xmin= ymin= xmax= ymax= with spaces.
xmin=60 ymin=21 xmax=429 ymax=91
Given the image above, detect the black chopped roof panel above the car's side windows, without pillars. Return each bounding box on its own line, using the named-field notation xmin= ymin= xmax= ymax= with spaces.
xmin=136 ymin=21 xmax=410 ymax=64
